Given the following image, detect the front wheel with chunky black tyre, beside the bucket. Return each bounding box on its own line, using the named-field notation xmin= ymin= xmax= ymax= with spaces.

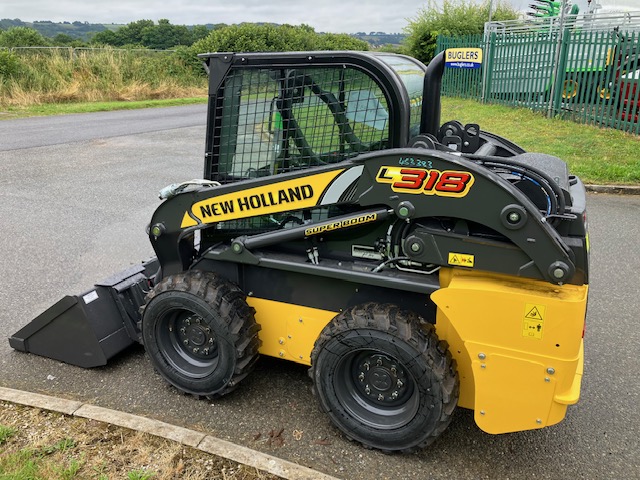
xmin=142 ymin=270 xmax=260 ymax=398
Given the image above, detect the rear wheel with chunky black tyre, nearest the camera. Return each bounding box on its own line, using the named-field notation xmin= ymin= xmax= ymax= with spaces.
xmin=310 ymin=303 xmax=459 ymax=452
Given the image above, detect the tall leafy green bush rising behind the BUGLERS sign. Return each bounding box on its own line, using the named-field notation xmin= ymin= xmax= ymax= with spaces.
xmin=405 ymin=0 xmax=518 ymax=63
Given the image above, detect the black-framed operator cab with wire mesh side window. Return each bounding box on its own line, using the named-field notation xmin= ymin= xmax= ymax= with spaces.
xmin=201 ymin=52 xmax=425 ymax=183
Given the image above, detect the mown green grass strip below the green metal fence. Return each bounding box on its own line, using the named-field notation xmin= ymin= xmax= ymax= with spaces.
xmin=442 ymin=98 xmax=640 ymax=185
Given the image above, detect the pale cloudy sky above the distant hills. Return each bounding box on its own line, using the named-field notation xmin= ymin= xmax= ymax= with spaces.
xmin=0 ymin=0 xmax=640 ymax=33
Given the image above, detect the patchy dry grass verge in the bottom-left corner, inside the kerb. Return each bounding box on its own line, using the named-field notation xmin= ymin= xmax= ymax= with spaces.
xmin=0 ymin=402 xmax=279 ymax=480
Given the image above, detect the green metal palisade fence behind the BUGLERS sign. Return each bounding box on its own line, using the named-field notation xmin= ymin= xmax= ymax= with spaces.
xmin=437 ymin=28 xmax=640 ymax=134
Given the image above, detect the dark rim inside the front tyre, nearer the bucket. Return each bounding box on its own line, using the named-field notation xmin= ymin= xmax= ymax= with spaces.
xmin=156 ymin=309 xmax=218 ymax=379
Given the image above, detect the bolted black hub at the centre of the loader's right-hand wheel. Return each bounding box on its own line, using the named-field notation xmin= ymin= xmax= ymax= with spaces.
xmin=355 ymin=353 xmax=410 ymax=406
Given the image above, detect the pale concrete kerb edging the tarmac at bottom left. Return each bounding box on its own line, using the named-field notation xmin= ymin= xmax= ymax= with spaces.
xmin=0 ymin=387 xmax=338 ymax=480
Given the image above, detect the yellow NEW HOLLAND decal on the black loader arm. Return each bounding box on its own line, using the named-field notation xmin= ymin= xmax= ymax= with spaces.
xmin=180 ymin=169 xmax=344 ymax=228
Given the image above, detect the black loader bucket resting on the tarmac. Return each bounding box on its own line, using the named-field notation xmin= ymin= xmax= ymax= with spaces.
xmin=9 ymin=258 xmax=158 ymax=368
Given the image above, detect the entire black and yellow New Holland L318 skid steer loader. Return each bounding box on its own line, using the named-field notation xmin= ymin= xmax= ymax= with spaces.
xmin=10 ymin=52 xmax=589 ymax=452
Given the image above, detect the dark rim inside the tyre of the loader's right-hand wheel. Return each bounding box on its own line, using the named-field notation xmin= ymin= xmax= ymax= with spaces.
xmin=334 ymin=350 xmax=419 ymax=430
